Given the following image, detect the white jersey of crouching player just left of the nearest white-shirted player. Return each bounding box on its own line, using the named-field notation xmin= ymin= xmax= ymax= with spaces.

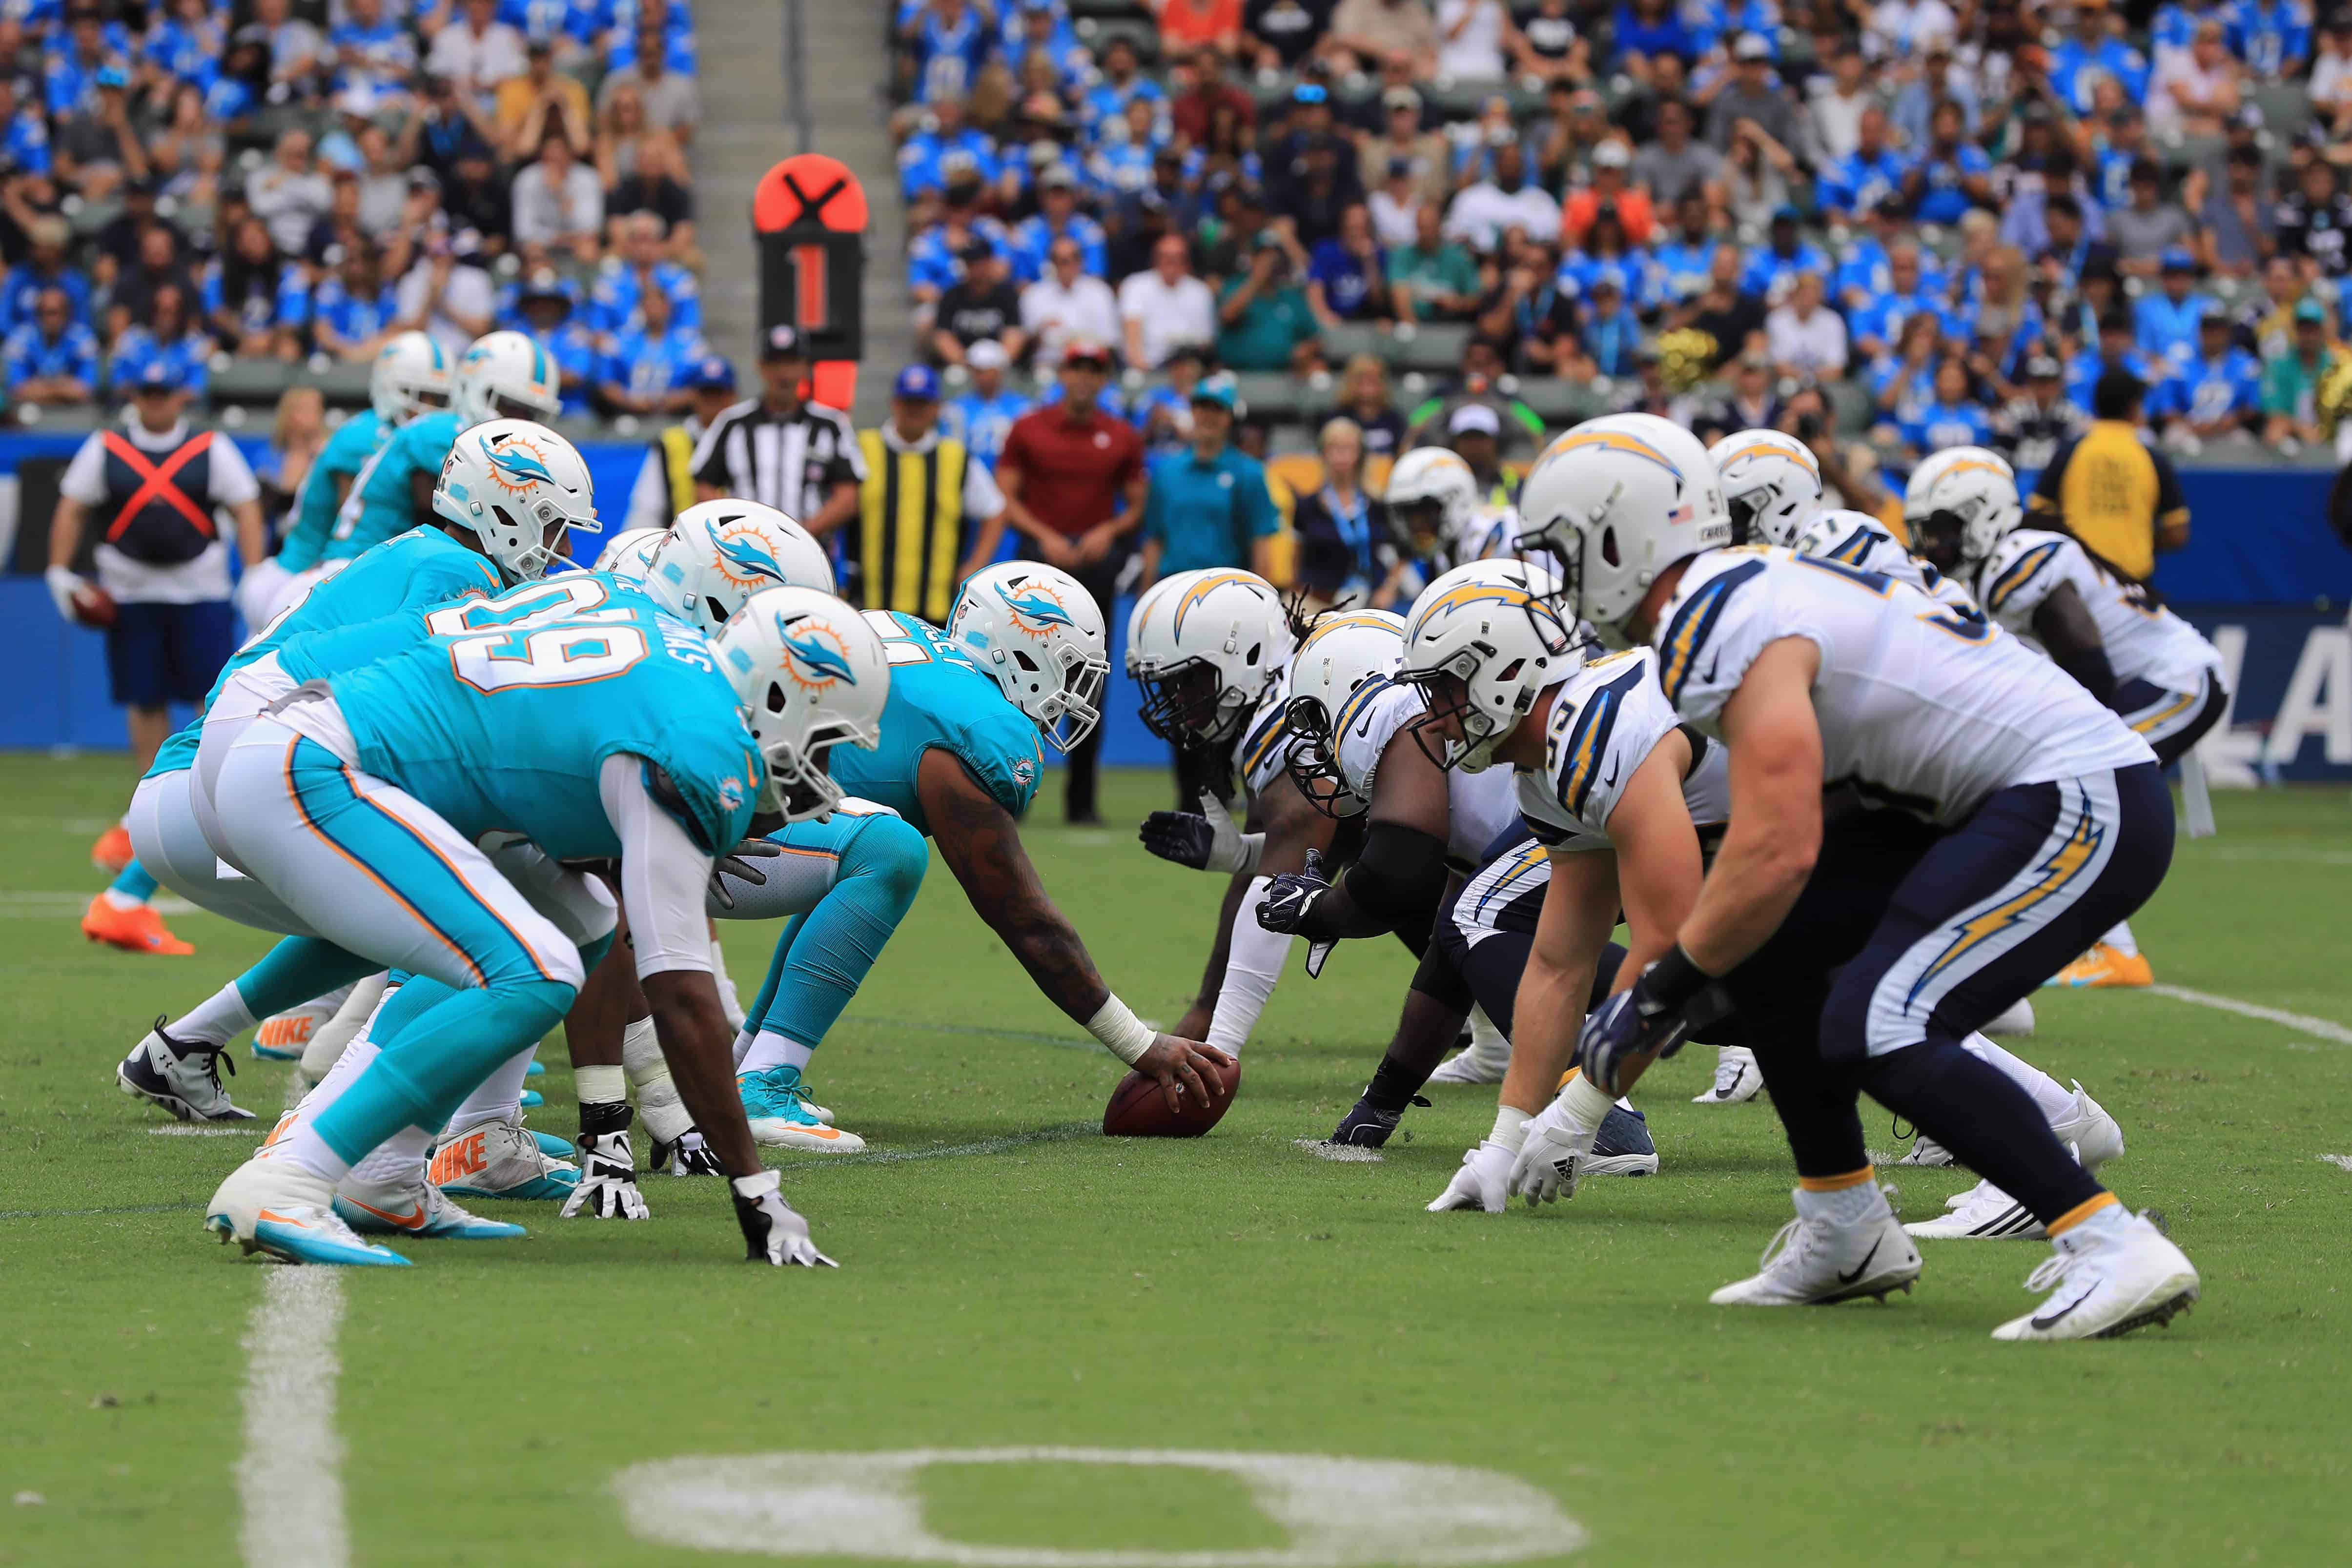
xmin=1517 ymin=649 xmax=1731 ymax=851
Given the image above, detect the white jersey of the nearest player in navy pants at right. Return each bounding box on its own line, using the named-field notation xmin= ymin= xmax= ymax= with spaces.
xmin=1654 ymin=548 xmax=2154 ymax=825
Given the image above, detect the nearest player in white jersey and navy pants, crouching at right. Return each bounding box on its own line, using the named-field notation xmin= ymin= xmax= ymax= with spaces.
xmin=1505 ymin=416 xmax=2197 ymax=1340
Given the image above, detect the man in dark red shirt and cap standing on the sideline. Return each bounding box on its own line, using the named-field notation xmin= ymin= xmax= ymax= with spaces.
xmin=997 ymin=343 xmax=1143 ymax=823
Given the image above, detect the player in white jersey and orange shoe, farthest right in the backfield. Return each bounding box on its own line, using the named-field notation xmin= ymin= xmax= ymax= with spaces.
xmin=1903 ymin=447 xmax=2229 ymax=985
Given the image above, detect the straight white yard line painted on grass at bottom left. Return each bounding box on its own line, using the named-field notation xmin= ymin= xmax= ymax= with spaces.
xmin=238 ymin=1265 xmax=350 ymax=1568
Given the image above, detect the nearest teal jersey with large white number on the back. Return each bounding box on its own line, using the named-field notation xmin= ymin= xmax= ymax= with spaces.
xmin=327 ymin=573 xmax=762 ymax=860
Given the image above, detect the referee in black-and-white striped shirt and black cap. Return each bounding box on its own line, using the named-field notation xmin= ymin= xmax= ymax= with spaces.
xmin=694 ymin=327 xmax=865 ymax=538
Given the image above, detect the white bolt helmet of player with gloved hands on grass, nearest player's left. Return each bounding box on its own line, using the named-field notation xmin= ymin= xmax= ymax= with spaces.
xmin=1397 ymin=557 xmax=1561 ymax=774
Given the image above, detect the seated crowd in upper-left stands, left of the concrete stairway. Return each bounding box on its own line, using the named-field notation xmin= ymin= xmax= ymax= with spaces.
xmin=0 ymin=0 xmax=710 ymax=416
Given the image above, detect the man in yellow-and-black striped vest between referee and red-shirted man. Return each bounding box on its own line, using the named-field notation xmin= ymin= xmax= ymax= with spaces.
xmin=860 ymin=365 xmax=1004 ymax=625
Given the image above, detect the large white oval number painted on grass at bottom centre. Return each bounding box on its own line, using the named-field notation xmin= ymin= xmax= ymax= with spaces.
xmin=614 ymin=1448 xmax=1590 ymax=1568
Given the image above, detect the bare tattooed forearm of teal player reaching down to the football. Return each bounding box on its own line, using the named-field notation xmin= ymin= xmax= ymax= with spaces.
xmin=915 ymin=748 xmax=1110 ymax=1022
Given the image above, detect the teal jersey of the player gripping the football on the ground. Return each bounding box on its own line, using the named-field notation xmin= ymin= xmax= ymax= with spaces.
xmin=828 ymin=609 xmax=1044 ymax=835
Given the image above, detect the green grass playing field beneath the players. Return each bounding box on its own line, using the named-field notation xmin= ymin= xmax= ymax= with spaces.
xmin=0 ymin=757 xmax=2352 ymax=1568
